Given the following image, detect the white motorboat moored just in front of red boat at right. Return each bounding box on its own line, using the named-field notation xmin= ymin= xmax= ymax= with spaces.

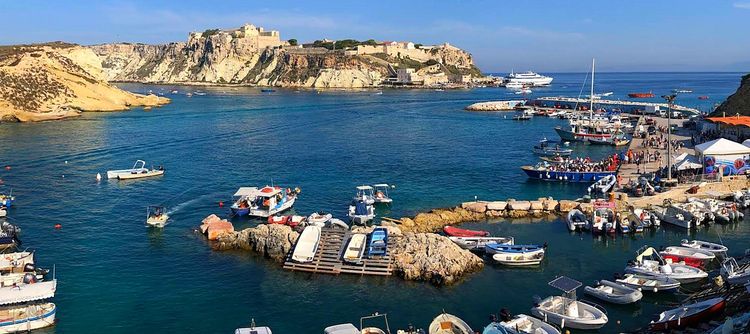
xmin=625 ymin=247 xmax=708 ymax=284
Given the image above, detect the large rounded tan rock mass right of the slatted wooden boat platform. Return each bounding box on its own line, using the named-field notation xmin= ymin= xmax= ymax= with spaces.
xmin=392 ymin=233 xmax=484 ymax=285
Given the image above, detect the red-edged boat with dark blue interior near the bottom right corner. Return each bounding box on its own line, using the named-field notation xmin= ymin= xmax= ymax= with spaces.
xmin=649 ymin=297 xmax=726 ymax=331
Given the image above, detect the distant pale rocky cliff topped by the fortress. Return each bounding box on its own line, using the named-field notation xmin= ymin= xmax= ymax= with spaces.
xmin=90 ymin=26 xmax=479 ymax=88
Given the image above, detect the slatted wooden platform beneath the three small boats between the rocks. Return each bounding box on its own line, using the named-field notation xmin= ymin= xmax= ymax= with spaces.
xmin=284 ymin=228 xmax=399 ymax=276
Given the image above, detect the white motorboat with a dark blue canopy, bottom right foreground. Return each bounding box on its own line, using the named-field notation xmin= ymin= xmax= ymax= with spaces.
xmin=531 ymin=276 xmax=609 ymax=329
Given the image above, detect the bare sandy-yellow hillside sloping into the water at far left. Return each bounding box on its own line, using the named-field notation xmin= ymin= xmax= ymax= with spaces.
xmin=0 ymin=43 xmax=169 ymax=122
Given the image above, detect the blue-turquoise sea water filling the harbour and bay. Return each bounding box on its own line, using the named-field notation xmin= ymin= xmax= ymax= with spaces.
xmin=0 ymin=73 xmax=750 ymax=333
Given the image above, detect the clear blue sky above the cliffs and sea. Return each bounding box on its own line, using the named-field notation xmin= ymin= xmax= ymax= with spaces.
xmin=0 ymin=0 xmax=750 ymax=73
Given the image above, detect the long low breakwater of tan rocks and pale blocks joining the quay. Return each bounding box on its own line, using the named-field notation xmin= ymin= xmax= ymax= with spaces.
xmin=399 ymin=197 xmax=591 ymax=233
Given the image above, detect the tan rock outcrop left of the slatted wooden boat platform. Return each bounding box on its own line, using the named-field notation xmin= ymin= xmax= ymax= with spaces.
xmin=211 ymin=224 xmax=299 ymax=262
